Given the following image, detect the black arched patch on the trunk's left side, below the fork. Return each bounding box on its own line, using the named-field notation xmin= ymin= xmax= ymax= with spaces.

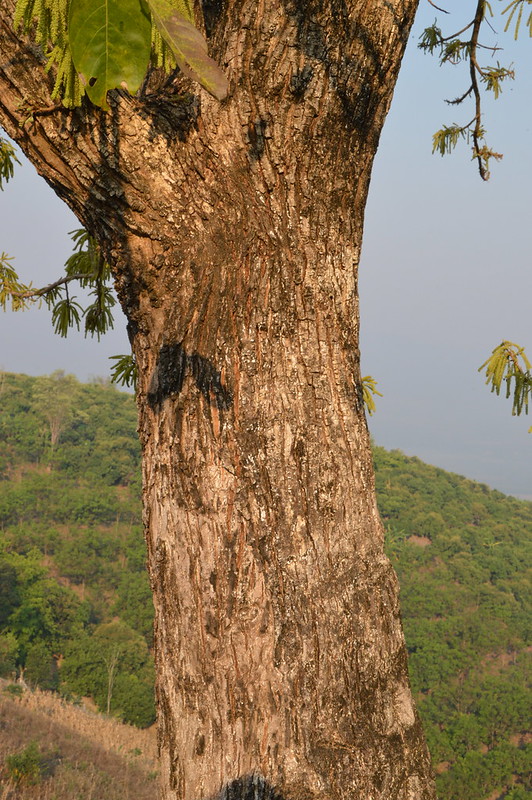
xmin=148 ymin=342 xmax=233 ymax=411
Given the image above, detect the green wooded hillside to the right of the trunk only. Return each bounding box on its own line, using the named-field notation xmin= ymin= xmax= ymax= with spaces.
xmin=375 ymin=448 xmax=532 ymax=800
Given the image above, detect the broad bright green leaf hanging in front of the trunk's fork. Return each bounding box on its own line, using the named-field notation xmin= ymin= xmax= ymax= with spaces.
xmin=68 ymin=0 xmax=151 ymax=109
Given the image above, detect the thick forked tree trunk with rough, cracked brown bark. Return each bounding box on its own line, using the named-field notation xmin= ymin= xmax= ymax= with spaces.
xmin=0 ymin=0 xmax=434 ymax=800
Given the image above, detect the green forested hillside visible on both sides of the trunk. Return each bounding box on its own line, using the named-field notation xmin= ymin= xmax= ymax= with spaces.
xmin=0 ymin=373 xmax=532 ymax=800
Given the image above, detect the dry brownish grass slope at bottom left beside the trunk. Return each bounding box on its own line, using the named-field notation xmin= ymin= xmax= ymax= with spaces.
xmin=0 ymin=686 xmax=157 ymax=800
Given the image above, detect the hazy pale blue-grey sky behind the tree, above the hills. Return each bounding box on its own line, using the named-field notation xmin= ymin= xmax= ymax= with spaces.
xmin=0 ymin=0 xmax=532 ymax=499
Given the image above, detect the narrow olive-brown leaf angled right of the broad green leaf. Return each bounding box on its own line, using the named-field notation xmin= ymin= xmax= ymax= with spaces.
xmin=147 ymin=0 xmax=228 ymax=100
